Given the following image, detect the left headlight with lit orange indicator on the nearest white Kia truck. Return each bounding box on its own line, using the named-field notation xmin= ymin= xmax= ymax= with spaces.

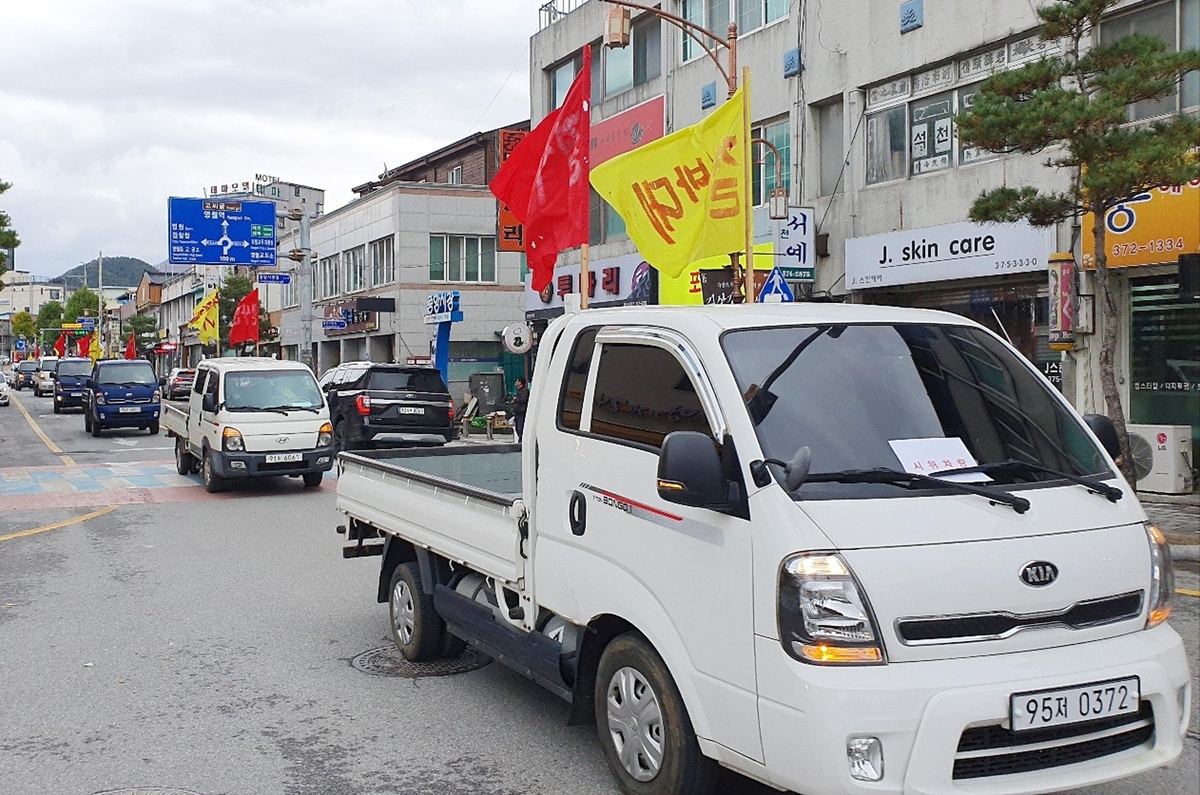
xmin=779 ymin=552 xmax=886 ymax=665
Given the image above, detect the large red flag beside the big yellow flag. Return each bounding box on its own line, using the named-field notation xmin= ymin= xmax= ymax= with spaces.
xmin=488 ymin=47 xmax=592 ymax=291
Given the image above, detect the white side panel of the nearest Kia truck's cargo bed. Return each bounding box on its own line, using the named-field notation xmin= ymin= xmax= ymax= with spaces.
xmin=337 ymin=456 xmax=523 ymax=584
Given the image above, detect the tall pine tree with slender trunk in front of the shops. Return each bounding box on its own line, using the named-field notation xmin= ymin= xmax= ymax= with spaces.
xmin=956 ymin=0 xmax=1200 ymax=483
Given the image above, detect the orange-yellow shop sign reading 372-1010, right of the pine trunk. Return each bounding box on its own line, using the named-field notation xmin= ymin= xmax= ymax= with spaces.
xmin=1080 ymin=180 xmax=1200 ymax=269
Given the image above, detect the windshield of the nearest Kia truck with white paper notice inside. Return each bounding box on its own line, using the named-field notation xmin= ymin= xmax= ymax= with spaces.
xmin=721 ymin=324 xmax=1110 ymax=496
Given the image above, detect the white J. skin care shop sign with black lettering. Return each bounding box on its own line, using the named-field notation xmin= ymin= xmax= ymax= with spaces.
xmin=846 ymin=221 xmax=1052 ymax=289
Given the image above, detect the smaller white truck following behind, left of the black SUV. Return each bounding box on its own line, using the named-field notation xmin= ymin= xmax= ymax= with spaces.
xmin=162 ymin=357 xmax=334 ymax=491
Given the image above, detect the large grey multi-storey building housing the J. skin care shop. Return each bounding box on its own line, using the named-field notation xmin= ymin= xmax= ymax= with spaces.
xmin=527 ymin=0 xmax=1200 ymax=461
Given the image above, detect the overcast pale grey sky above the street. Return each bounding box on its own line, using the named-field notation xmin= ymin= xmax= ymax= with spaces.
xmin=0 ymin=0 xmax=542 ymax=276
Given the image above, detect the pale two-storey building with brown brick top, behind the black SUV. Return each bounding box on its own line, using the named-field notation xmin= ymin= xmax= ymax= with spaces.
xmin=279 ymin=122 xmax=528 ymax=396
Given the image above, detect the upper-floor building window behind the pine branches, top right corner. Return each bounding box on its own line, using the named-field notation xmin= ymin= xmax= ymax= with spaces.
xmin=1100 ymin=0 xmax=1200 ymax=121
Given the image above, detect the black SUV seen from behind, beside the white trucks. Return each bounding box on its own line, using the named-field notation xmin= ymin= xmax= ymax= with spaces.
xmin=320 ymin=361 xmax=454 ymax=450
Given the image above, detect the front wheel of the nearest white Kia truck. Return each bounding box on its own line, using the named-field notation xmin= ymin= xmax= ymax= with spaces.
xmin=595 ymin=632 xmax=718 ymax=795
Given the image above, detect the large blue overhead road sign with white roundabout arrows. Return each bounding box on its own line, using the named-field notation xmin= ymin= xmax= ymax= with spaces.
xmin=167 ymin=197 xmax=275 ymax=268
